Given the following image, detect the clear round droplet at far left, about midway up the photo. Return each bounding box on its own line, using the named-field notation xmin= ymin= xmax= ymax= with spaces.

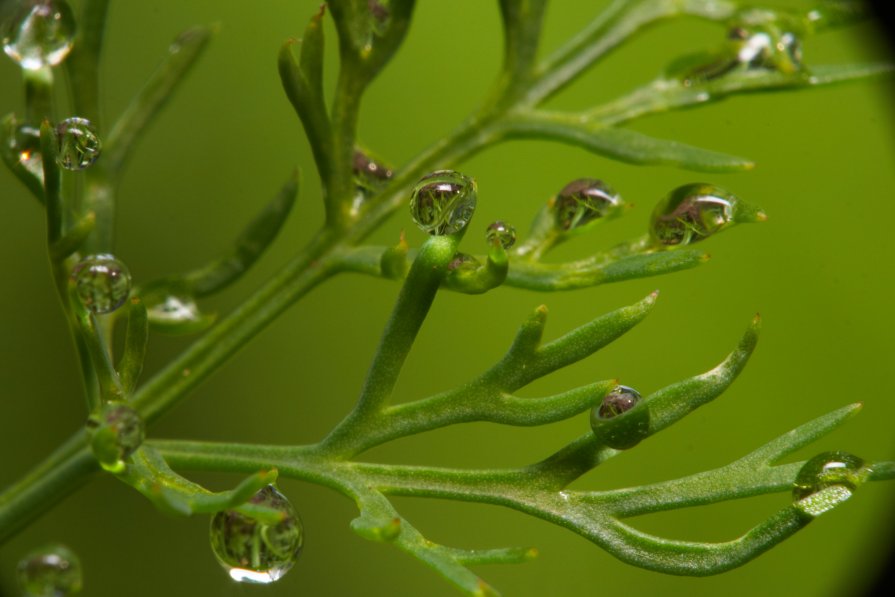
xmin=71 ymin=253 xmax=131 ymax=314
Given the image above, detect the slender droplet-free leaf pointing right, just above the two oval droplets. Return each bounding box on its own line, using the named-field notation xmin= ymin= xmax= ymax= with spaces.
xmin=506 ymin=112 xmax=755 ymax=172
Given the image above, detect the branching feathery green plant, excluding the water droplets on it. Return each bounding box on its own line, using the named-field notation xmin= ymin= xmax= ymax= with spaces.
xmin=0 ymin=0 xmax=895 ymax=595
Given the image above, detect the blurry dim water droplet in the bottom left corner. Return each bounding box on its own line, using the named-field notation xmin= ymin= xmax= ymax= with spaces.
xmin=17 ymin=544 xmax=82 ymax=597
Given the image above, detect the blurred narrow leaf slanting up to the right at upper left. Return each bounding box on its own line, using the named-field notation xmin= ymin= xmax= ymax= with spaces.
xmin=104 ymin=27 xmax=215 ymax=172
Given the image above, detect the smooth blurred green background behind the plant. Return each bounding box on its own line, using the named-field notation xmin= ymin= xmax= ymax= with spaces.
xmin=0 ymin=0 xmax=895 ymax=597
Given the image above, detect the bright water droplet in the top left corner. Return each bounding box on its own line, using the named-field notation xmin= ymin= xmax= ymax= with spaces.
xmin=3 ymin=0 xmax=75 ymax=70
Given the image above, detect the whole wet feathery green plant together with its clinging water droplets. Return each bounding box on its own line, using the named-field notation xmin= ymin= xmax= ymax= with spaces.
xmin=0 ymin=0 xmax=895 ymax=595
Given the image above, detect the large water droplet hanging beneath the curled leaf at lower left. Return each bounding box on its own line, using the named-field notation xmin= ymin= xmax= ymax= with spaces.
xmin=211 ymin=485 xmax=304 ymax=584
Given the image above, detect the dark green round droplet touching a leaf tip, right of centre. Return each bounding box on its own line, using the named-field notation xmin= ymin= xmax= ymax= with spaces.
xmin=590 ymin=385 xmax=649 ymax=450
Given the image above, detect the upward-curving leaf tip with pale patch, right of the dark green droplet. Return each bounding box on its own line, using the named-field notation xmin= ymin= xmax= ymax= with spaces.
xmin=646 ymin=315 xmax=761 ymax=434
